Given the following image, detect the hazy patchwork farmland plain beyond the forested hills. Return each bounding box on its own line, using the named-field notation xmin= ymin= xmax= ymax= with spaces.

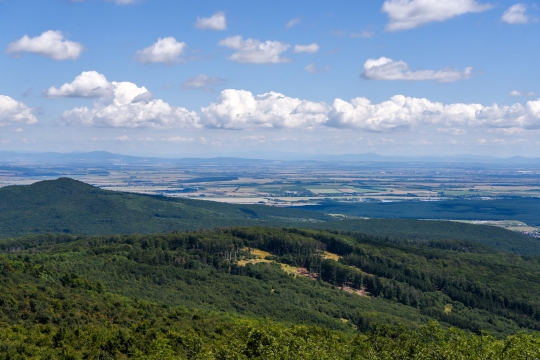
xmin=0 ymin=153 xmax=540 ymax=236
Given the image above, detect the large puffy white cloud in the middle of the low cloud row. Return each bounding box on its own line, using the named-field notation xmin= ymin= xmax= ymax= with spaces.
xmin=201 ymin=89 xmax=329 ymax=130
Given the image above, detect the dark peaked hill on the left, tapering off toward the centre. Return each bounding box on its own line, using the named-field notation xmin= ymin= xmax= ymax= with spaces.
xmin=0 ymin=178 xmax=332 ymax=238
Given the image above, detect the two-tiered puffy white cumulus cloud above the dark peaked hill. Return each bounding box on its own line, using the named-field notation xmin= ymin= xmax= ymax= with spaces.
xmin=51 ymin=71 xmax=199 ymax=128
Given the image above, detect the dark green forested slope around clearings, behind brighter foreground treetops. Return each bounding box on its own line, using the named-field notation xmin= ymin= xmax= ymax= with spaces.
xmin=0 ymin=227 xmax=540 ymax=336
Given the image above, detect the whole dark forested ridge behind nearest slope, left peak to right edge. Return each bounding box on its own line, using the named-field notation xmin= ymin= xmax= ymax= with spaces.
xmin=0 ymin=178 xmax=540 ymax=254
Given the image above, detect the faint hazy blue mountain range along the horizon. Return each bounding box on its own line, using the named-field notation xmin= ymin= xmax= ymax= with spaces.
xmin=0 ymin=151 xmax=540 ymax=166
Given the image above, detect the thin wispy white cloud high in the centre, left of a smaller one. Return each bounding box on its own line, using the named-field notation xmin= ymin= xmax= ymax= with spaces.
xmin=219 ymin=36 xmax=291 ymax=64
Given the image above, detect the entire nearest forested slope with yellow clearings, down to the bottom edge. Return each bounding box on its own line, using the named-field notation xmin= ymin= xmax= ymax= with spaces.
xmin=0 ymin=227 xmax=540 ymax=359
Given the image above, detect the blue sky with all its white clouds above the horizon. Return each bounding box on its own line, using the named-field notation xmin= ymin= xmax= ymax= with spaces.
xmin=0 ymin=0 xmax=540 ymax=157
